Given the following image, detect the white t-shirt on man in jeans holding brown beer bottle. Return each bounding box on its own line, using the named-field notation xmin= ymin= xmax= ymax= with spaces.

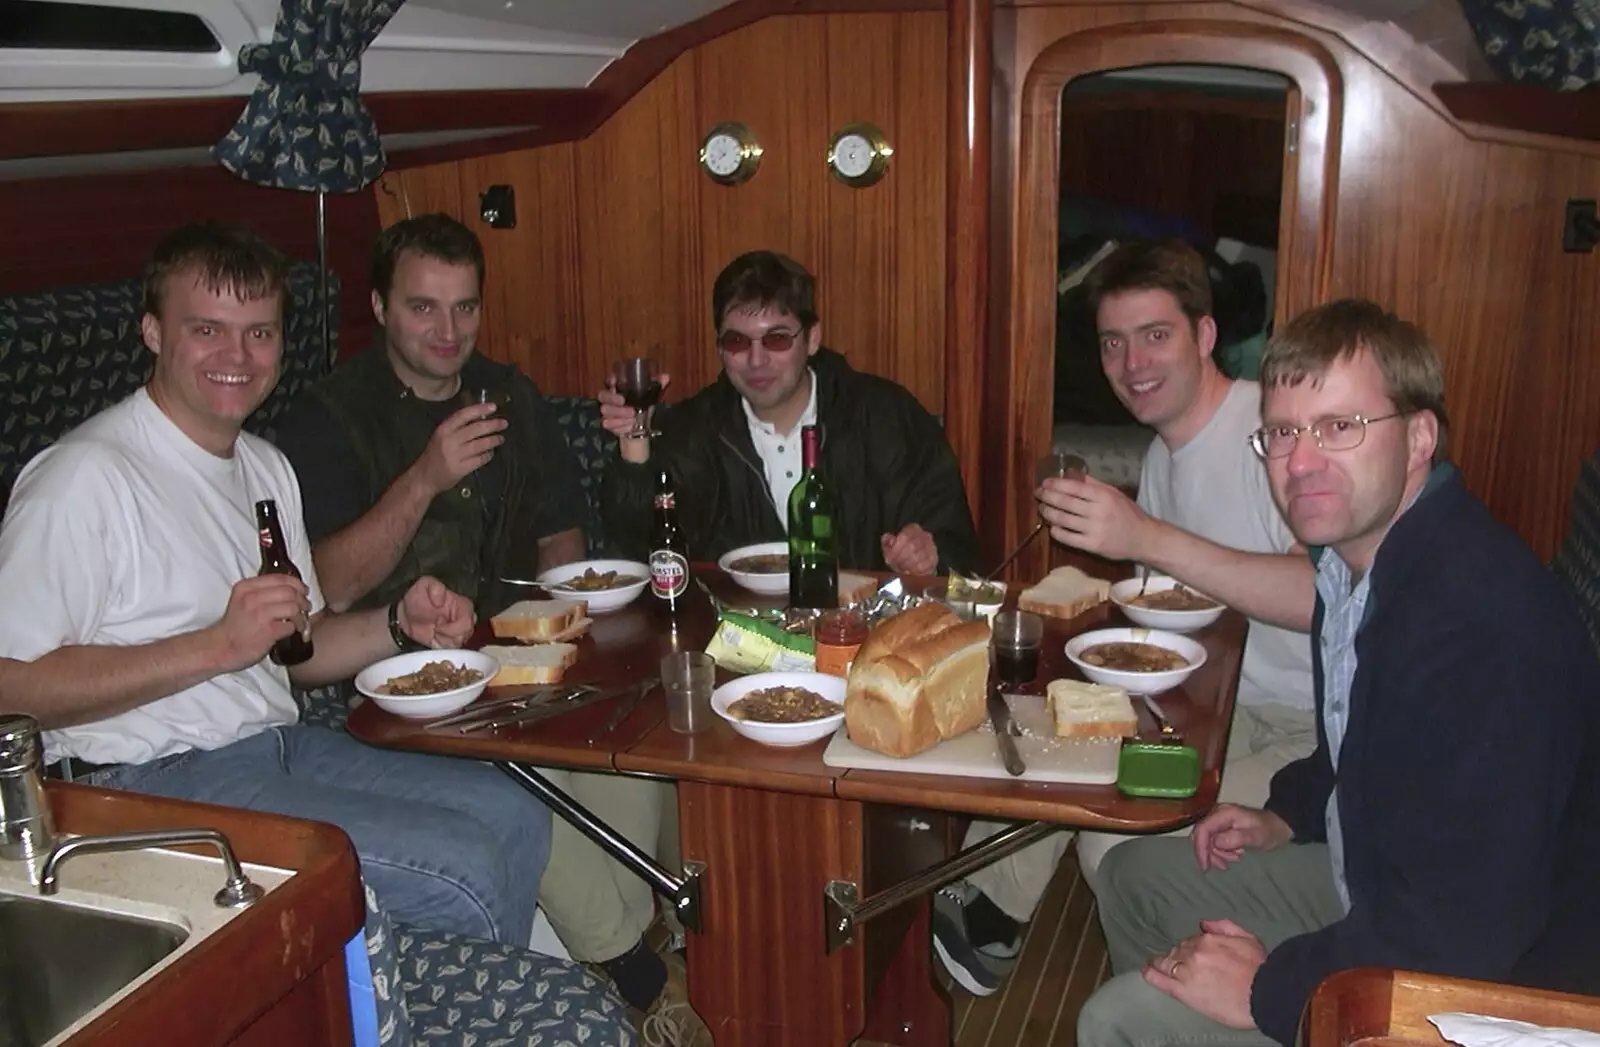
xmin=0 ymin=389 xmax=323 ymax=764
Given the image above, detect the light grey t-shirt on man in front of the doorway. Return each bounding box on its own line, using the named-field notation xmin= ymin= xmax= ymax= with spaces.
xmin=1139 ymin=381 xmax=1315 ymax=711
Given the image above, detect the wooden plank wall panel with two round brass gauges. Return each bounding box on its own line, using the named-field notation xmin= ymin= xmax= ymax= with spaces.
xmin=376 ymin=11 xmax=946 ymax=411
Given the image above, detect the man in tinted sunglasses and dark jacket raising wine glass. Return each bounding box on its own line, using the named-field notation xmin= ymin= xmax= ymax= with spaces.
xmin=600 ymin=251 xmax=978 ymax=575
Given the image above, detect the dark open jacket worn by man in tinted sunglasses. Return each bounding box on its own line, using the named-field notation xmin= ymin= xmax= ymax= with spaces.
xmin=600 ymin=349 xmax=978 ymax=572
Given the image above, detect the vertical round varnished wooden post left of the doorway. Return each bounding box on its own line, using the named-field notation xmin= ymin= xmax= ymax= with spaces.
xmin=944 ymin=0 xmax=994 ymax=517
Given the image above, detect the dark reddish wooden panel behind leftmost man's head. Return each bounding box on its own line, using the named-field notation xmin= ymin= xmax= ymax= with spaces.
xmin=0 ymin=166 xmax=379 ymax=351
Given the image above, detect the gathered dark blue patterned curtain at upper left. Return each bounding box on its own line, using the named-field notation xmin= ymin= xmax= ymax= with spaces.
xmin=213 ymin=0 xmax=403 ymax=192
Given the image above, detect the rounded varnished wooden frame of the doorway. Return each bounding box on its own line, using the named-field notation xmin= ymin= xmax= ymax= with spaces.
xmin=1011 ymin=19 xmax=1344 ymax=578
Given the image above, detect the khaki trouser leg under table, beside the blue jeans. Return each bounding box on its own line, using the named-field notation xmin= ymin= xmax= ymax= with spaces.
xmin=539 ymin=767 xmax=677 ymax=964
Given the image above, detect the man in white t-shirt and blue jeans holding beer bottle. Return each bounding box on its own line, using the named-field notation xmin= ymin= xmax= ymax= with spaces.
xmin=0 ymin=223 xmax=550 ymax=945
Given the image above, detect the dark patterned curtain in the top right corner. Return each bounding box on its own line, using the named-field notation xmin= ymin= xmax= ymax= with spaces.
xmin=1461 ymin=0 xmax=1600 ymax=91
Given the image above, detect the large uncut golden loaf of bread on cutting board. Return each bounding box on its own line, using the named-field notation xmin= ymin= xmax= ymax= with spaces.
xmin=845 ymin=604 xmax=989 ymax=757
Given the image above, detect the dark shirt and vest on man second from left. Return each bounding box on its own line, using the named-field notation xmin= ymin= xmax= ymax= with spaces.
xmin=278 ymin=341 xmax=582 ymax=615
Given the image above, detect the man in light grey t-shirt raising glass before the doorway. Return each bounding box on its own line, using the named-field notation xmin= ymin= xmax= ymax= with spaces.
xmin=934 ymin=242 xmax=1317 ymax=991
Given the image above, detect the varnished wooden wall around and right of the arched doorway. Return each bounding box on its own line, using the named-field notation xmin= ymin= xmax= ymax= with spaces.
xmin=1003 ymin=2 xmax=1600 ymax=566
